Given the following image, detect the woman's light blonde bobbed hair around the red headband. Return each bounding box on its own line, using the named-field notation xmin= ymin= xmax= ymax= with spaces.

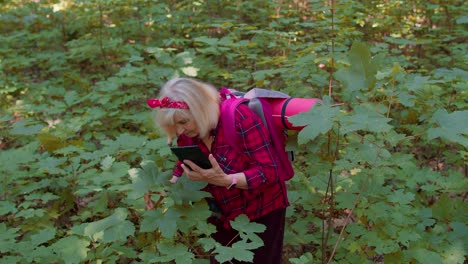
xmin=155 ymin=78 xmax=220 ymax=141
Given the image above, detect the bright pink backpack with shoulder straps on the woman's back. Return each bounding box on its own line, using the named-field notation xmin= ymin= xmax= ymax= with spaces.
xmin=220 ymin=88 xmax=294 ymax=181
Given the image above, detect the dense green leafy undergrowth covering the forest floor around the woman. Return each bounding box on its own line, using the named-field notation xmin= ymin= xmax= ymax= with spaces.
xmin=0 ymin=0 xmax=468 ymax=263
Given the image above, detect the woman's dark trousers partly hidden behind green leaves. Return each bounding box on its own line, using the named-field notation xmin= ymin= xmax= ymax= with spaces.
xmin=210 ymin=208 xmax=286 ymax=264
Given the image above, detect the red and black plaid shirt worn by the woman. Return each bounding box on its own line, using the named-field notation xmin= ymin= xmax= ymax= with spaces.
xmin=174 ymin=104 xmax=289 ymax=227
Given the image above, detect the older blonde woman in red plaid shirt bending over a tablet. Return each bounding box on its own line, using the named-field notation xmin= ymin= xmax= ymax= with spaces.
xmin=148 ymin=78 xmax=289 ymax=263
